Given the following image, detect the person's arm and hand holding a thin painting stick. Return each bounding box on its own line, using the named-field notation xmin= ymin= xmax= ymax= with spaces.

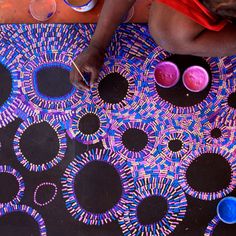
xmin=70 ymin=0 xmax=136 ymax=89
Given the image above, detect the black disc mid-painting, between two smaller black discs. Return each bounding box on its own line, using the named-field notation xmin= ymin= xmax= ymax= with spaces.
xmin=122 ymin=128 xmax=148 ymax=152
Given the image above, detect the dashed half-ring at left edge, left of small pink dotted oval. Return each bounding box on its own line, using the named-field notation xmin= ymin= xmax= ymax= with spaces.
xmin=0 ymin=165 xmax=25 ymax=208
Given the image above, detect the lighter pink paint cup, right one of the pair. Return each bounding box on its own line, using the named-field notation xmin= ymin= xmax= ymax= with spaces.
xmin=183 ymin=66 xmax=209 ymax=93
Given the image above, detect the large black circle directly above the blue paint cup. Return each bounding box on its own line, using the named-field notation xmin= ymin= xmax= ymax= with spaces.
xmin=186 ymin=153 xmax=231 ymax=192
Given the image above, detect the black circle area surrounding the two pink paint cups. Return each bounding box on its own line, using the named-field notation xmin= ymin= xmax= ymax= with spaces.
xmin=156 ymin=55 xmax=212 ymax=107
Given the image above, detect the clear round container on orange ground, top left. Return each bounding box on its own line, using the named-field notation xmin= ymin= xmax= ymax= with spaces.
xmin=29 ymin=0 xmax=57 ymax=22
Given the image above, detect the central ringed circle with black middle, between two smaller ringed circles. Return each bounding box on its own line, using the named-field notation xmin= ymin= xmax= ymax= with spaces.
xmin=103 ymin=119 xmax=162 ymax=162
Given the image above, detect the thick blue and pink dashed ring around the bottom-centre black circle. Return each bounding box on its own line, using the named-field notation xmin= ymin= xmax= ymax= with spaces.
xmin=119 ymin=178 xmax=187 ymax=236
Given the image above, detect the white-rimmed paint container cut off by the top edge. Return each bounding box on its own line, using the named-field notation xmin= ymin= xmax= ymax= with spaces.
xmin=64 ymin=0 xmax=97 ymax=12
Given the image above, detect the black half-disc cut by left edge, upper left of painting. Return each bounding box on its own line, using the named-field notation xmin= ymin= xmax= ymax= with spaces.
xmin=0 ymin=64 xmax=12 ymax=107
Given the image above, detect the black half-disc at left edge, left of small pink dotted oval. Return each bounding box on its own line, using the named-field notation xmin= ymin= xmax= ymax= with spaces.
xmin=0 ymin=173 xmax=19 ymax=203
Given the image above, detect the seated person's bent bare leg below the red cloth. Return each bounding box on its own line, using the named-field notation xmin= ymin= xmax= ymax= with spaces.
xmin=150 ymin=3 xmax=236 ymax=57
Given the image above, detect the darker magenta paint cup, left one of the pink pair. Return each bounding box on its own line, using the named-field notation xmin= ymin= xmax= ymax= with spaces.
xmin=154 ymin=61 xmax=180 ymax=88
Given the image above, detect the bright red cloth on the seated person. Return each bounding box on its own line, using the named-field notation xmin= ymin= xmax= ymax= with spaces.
xmin=157 ymin=0 xmax=228 ymax=31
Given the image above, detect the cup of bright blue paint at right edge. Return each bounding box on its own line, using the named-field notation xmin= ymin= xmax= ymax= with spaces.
xmin=217 ymin=197 xmax=236 ymax=224
